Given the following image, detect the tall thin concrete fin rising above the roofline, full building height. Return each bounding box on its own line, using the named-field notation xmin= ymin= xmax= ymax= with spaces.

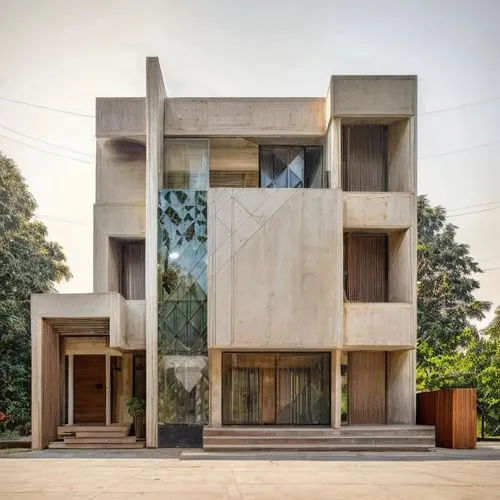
xmin=145 ymin=57 xmax=166 ymax=448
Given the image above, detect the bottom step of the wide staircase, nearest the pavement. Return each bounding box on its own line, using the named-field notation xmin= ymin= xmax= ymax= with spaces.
xmin=203 ymin=444 xmax=434 ymax=452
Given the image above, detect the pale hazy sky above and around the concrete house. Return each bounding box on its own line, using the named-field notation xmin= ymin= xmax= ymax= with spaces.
xmin=0 ymin=0 xmax=500 ymax=326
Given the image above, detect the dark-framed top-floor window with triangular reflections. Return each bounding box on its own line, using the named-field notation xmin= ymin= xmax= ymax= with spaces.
xmin=259 ymin=146 xmax=323 ymax=188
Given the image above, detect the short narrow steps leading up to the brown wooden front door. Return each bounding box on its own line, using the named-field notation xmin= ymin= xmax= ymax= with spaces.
xmin=49 ymin=424 xmax=144 ymax=449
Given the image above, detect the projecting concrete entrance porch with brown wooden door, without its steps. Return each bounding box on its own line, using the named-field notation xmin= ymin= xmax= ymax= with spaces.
xmin=31 ymin=293 xmax=132 ymax=449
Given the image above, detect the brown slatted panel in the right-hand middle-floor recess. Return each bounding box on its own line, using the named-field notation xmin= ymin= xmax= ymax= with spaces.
xmin=344 ymin=233 xmax=389 ymax=302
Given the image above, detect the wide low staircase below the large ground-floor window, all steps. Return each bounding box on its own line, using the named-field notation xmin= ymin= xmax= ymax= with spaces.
xmin=203 ymin=425 xmax=435 ymax=452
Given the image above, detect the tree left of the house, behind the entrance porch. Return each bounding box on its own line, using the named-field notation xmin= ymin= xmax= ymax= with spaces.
xmin=0 ymin=154 xmax=71 ymax=434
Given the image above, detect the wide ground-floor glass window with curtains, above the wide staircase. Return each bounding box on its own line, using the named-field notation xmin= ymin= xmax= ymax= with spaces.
xmin=222 ymin=353 xmax=330 ymax=425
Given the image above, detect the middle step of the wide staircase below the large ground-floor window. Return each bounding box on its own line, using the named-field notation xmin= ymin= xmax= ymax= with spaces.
xmin=203 ymin=436 xmax=435 ymax=448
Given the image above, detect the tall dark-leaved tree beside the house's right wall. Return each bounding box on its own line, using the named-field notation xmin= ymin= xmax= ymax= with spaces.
xmin=417 ymin=196 xmax=491 ymax=362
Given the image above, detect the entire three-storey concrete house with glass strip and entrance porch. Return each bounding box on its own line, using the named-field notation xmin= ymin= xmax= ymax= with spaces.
xmin=32 ymin=58 xmax=434 ymax=450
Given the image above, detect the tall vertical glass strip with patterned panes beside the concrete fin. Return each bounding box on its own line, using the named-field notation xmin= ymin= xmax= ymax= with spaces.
xmin=158 ymin=140 xmax=208 ymax=424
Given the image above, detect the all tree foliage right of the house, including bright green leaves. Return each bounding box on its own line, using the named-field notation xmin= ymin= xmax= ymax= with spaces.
xmin=417 ymin=196 xmax=500 ymax=433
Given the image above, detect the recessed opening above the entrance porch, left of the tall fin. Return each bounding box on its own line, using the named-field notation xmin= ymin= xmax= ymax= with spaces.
xmin=109 ymin=238 xmax=145 ymax=300
